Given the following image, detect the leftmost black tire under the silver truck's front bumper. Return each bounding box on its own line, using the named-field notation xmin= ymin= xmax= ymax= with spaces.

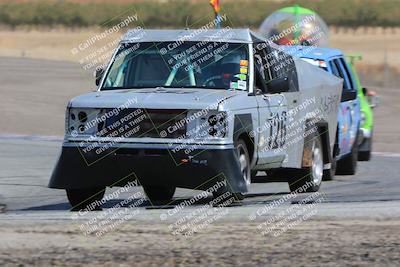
xmin=65 ymin=187 xmax=106 ymax=211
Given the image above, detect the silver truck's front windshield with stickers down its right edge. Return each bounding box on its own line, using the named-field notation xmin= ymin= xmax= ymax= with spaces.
xmin=101 ymin=41 xmax=249 ymax=90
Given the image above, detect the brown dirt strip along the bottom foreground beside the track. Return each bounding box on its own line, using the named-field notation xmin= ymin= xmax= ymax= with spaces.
xmin=0 ymin=219 xmax=400 ymax=267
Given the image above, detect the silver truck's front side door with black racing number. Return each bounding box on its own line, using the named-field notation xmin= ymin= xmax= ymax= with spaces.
xmin=254 ymin=46 xmax=288 ymax=168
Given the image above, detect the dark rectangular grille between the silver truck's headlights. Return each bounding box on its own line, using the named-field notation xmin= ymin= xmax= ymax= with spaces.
xmin=97 ymin=109 xmax=187 ymax=138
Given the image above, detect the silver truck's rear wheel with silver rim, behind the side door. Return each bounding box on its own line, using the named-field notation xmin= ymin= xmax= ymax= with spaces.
xmin=289 ymin=134 xmax=324 ymax=193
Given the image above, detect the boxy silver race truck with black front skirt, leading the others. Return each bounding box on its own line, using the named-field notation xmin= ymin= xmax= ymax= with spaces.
xmin=49 ymin=29 xmax=342 ymax=209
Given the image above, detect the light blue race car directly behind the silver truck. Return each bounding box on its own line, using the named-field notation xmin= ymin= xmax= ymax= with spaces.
xmin=281 ymin=46 xmax=365 ymax=180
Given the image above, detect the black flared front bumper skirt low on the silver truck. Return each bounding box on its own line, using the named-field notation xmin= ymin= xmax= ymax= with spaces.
xmin=49 ymin=142 xmax=247 ymax=193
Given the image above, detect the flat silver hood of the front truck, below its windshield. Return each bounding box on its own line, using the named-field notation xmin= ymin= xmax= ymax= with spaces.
xmin=68 ymin=88 xmax=242 ymax=109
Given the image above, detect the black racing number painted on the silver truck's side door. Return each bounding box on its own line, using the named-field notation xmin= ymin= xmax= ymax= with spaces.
xmin=267 ymin=111 xmax=287 ymax=149
